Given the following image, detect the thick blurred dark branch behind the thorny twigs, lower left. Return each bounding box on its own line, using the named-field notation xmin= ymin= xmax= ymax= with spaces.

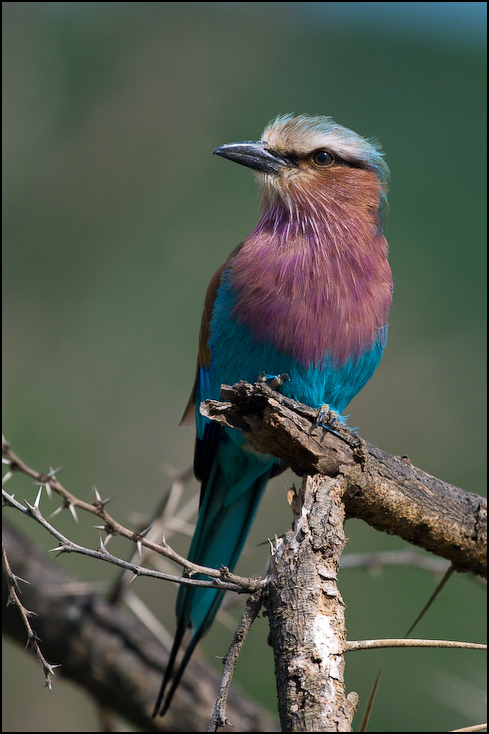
xmin=2 ymin=523 xmax=278 ymax=731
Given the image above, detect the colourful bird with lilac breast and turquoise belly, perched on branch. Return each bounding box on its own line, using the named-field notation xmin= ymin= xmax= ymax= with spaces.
xmin=154 ymin=114 xmax=393 ymax=715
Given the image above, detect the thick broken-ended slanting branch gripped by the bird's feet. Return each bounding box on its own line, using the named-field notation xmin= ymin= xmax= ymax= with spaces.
xmin=201 ymin=382 xmax=487 ymax=577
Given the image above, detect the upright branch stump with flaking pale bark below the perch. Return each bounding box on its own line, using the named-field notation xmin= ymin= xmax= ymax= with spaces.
xmin=264 ymin=475 xmax=358 ymax=731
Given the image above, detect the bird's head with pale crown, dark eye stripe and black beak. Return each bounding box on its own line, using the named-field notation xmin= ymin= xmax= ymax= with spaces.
xmin=214 ymin=115 xmax=389 ymax=224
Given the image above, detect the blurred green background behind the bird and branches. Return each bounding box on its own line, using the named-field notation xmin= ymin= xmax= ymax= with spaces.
xmin=3 ymin=2 xmax=486 ymax=731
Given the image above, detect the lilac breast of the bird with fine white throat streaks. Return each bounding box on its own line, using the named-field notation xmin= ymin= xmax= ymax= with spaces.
xmin=230 ymin=197 xmax=392 ymax=367
